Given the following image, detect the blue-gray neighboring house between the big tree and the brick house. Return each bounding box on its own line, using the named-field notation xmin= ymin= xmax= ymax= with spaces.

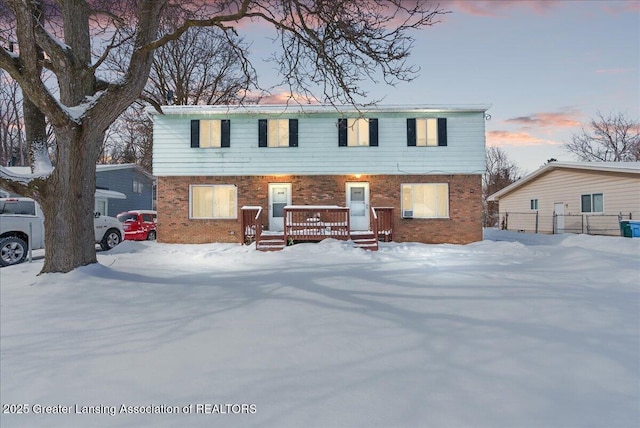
xmin=96 ymin=163 xmax=155 ymax=216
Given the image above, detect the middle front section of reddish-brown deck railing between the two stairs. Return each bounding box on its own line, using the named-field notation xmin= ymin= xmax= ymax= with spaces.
xmin=284 ymin=205 xmax=350 ymax=242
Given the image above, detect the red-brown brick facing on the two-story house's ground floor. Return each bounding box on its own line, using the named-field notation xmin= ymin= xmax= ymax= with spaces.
xmin=157 ymin=174 xmax=482 ymax=244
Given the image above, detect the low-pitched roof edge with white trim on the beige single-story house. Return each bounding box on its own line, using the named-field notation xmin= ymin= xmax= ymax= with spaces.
xmin=487 ymin=162 xmax=640 ymax=202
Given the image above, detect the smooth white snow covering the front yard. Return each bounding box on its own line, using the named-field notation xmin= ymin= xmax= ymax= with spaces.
xmin=0 ymin=230 xmax=640 ymax=428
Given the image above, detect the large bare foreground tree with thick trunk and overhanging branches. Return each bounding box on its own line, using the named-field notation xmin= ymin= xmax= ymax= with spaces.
xmin=0 ymin=0 xmax=444 ymax=273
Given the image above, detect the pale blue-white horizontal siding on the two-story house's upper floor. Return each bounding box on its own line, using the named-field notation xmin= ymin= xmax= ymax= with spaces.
xmin=153 ymin=112 xmax=485 ymax=176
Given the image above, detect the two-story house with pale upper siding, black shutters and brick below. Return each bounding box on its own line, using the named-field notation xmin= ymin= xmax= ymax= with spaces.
xmin=149 ymin=105 xmax=489 ymax=247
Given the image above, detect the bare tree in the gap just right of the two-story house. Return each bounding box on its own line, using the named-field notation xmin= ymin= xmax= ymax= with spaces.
xmin=482 ymin=147 xmax=520 ymax=227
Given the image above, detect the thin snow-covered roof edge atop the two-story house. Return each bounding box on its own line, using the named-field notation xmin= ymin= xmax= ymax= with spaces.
xmin=146 ymin=103 xmax=491 ymax=115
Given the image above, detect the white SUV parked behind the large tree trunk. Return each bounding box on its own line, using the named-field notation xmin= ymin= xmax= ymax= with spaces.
xmin=0 ymin=198 xmax=124 ymax=266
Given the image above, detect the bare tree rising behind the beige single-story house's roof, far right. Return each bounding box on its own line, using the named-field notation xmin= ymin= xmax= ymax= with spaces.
xmin=565 ymin=112 xmax=640 ymax=162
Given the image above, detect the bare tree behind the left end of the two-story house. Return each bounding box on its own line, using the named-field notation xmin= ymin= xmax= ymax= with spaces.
xmin=100 ymin=25 xmax=258 ymax=172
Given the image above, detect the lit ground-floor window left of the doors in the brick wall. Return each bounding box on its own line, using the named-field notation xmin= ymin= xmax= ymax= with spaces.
xmin=189 ymin=184 xmax=237 ymax=219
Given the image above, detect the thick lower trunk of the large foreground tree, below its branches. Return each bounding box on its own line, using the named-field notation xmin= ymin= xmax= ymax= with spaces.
xmin=40 ymin=127 xmax=103 ymax=273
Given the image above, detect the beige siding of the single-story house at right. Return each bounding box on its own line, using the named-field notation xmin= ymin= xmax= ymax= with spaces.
xmin=499 ymin=169 xmax=640 ymax=232
